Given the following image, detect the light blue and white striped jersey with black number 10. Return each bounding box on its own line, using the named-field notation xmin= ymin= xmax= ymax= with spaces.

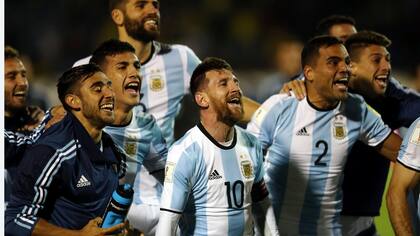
xmin=161 ymin=124 xmax=264 ymax=235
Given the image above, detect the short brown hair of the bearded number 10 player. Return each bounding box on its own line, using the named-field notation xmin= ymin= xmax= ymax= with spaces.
xmin=190 ymin=57 xmax=233 ymax=96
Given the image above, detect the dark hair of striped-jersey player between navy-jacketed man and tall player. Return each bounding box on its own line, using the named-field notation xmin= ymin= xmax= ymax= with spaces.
xmin=89 ymin=39 xmax=136 ymax=67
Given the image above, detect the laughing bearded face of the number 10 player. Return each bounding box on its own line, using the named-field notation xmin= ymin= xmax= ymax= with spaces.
xmin=204 ymin=69 xmax=244 ymax=125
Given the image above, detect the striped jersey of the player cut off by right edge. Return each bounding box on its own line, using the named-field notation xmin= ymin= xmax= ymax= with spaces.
xmin=397 ymin=117 xmax=420 ymax=231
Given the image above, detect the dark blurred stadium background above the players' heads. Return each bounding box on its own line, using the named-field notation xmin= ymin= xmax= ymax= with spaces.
xmin=5 ymin=0 xmax=420 ymax=106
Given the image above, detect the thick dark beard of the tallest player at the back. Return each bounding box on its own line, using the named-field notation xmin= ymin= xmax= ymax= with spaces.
xmin=124 ymin=15 xmax=160 ymax=43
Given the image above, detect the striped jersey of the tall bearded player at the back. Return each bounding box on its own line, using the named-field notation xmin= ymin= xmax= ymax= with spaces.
xmin=141 ymin=41 xmax=200 ymax=145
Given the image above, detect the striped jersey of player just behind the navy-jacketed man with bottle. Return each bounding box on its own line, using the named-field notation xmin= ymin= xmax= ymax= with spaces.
xmin=104 ymin=110 xmax=168 ymax=205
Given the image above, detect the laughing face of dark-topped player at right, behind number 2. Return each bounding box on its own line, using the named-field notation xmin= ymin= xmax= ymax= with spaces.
xmin=351 ymin=45 xmax=391 ymax=97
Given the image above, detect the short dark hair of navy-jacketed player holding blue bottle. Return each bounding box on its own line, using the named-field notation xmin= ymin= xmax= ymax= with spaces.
xmin=57 ymin=63 xmax=102 ymax=111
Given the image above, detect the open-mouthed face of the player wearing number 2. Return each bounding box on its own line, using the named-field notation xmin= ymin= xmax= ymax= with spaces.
xmin=305 ymin=44 xmax=350 ymax=105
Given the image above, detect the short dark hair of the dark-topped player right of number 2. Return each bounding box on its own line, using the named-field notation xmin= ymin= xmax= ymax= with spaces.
xmin=344 ymin=30 xmax=392 ymax=61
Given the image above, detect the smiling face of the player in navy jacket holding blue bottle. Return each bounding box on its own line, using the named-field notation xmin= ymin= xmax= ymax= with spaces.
xmin=76 ymin=72 xmax=115 ymax=130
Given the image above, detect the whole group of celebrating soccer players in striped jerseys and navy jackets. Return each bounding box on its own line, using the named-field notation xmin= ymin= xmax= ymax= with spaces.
xmin=5 ymin=0 xmax=420 ymax=235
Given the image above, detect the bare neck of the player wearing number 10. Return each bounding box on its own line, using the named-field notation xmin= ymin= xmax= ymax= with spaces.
xmin=200 ymin=112 xmax=234 ymax=142
